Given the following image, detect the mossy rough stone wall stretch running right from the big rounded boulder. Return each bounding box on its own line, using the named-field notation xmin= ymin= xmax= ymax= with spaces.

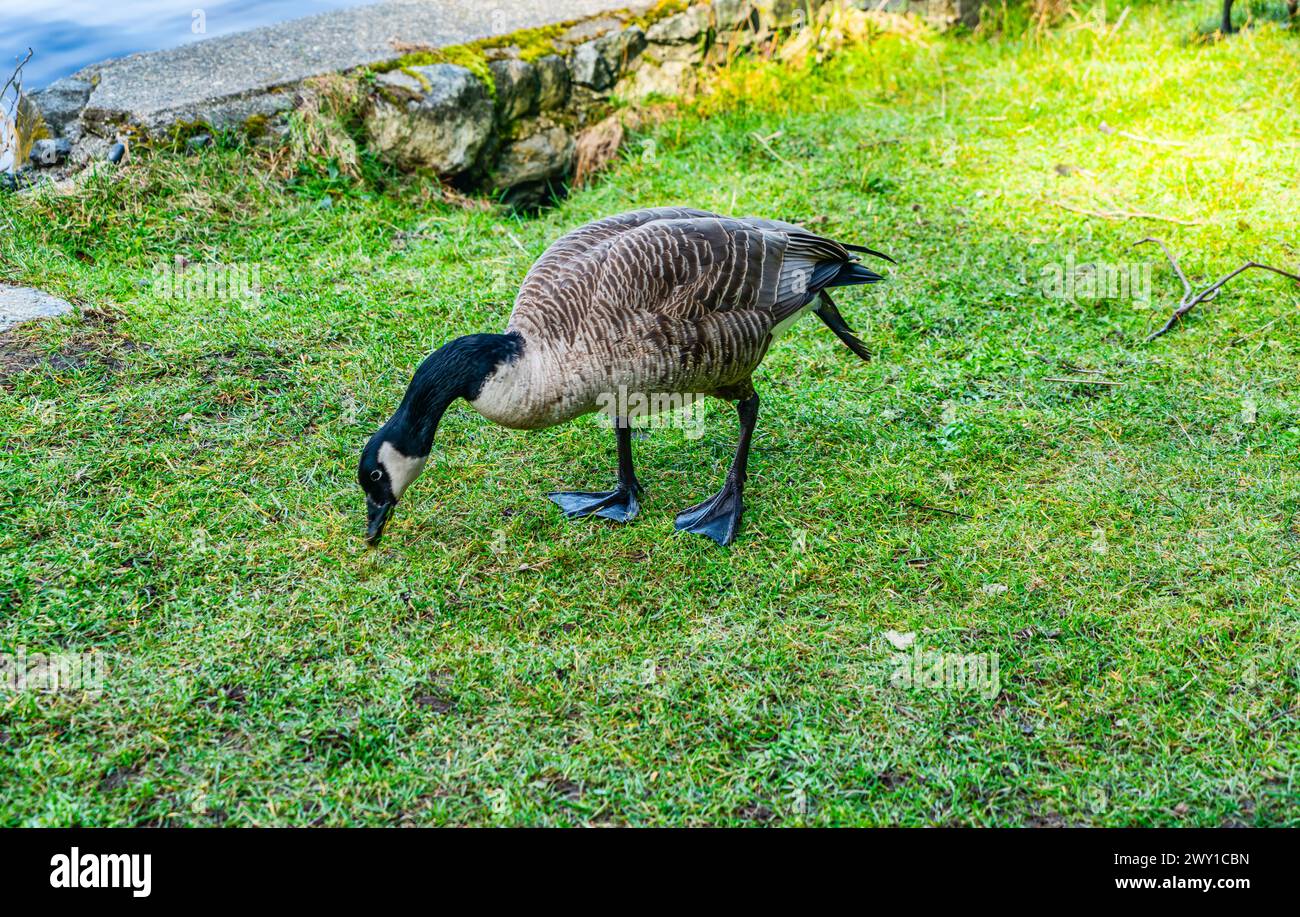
xmin=365 ymin=0 xmax=976 ymax=207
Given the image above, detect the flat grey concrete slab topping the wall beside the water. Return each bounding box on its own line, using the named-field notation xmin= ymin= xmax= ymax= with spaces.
xmin=78 ymin=0 xmax=651 ymax=126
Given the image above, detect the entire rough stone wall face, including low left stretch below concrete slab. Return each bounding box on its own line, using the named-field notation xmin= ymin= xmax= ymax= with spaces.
xmin=22 ymin=0 xmax=984 ymax=200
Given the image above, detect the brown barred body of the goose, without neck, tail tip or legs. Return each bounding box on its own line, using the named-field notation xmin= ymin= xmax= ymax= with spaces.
xmin=508 ymin=208 xmax=873 ymax=411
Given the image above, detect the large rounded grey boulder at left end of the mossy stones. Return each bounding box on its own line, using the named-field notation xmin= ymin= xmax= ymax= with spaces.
xmin=365 ymin=64 xmax=495 ymax=176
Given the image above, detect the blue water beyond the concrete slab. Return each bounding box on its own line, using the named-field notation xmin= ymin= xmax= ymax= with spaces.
xmin=0 ymin=0 xmax=374 ymax=90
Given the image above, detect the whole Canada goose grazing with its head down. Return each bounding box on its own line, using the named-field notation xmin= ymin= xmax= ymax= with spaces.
xmin=358 ymin=207 xmax=893 ymax=545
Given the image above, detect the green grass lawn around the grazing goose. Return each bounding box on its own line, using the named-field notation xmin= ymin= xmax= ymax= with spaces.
xmin=0 ymin=3 xmax=1300 ymax=825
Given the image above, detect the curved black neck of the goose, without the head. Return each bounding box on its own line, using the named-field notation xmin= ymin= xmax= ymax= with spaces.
xmin=389 ymin=332 xmax=524 ymax=455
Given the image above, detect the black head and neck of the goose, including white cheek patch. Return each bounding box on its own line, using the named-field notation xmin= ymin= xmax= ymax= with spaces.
xmin=356 ymin=334 xmax=523 ymax=546
